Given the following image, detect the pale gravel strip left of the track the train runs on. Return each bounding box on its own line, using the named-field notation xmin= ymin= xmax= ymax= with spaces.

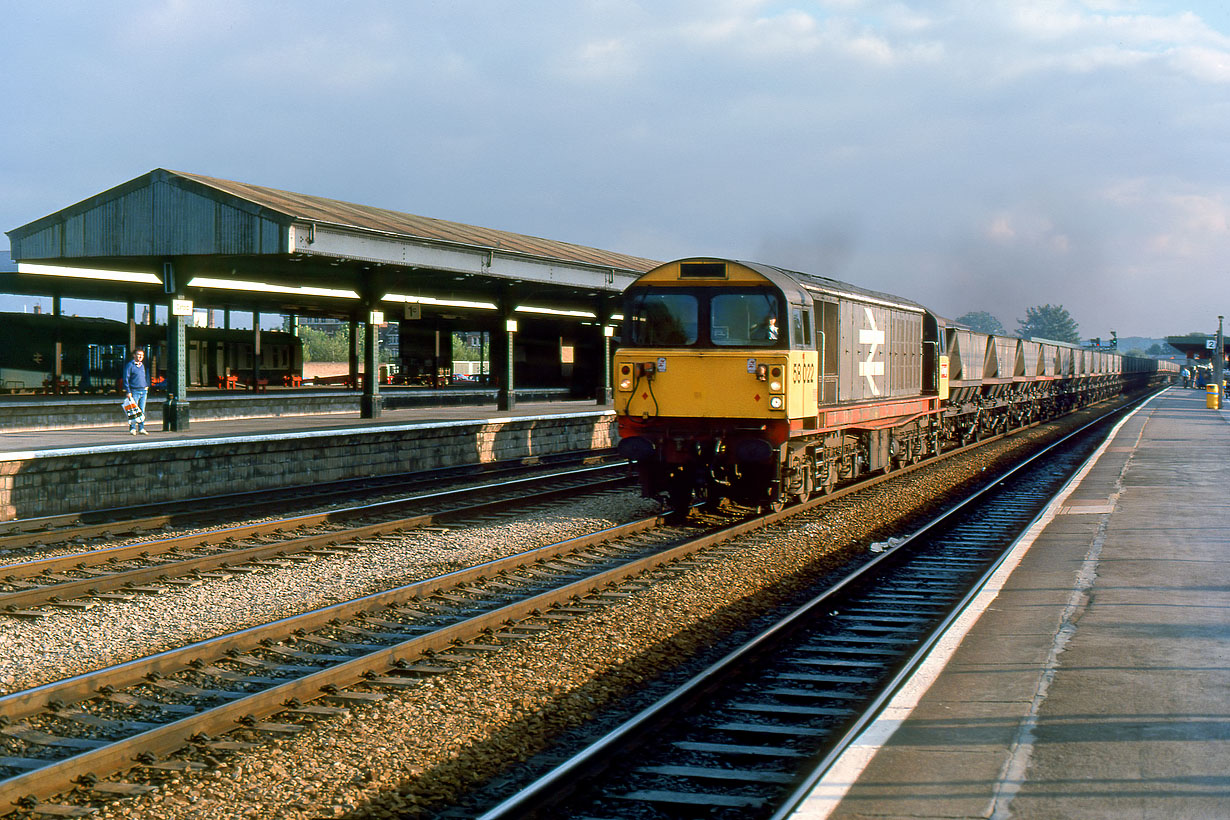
xmin=0 ymin=491 xmax=657 ymax=693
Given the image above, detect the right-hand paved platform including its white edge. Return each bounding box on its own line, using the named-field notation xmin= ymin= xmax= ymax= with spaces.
xmin=791 ymin=387 xmax=1230 ymax=820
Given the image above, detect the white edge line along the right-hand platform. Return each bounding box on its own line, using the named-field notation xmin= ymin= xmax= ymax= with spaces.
xmin=790 ymin=391 xmax=1166 ymax=820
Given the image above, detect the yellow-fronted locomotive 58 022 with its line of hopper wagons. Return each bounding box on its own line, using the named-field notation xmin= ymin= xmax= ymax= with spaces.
xmin=615 ymin=258 xmax=1177 ymax=514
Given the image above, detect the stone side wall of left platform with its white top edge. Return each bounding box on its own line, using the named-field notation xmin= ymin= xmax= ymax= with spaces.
xmin=0 ymin=412 xmax=617 ymax=521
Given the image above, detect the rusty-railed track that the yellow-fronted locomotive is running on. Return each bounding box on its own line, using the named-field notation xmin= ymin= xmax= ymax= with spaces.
xmin=0 ymin=393 xmax=1151 ymax=815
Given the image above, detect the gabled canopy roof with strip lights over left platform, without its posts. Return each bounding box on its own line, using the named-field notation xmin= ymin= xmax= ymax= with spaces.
xmin=0 ymin=168 xmax=657 ymax=321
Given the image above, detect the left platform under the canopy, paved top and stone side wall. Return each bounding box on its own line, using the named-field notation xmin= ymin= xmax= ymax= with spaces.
xmin=0 ymin=401 xmax=617 ymax=521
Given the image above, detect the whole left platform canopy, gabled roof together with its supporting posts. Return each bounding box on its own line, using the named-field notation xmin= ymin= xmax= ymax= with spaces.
xmin=0 ymin=168 xmax=657 ymax=430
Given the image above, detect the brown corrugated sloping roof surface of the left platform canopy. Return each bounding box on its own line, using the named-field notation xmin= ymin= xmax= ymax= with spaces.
xmin=166 ymin=171 xmax=658 ymax=273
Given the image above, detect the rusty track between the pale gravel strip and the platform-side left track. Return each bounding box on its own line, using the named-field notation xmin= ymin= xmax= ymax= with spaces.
xmin=0 ymin=465 xmax=627 ymax=617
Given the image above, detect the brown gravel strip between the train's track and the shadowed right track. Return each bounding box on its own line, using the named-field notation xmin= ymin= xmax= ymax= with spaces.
xmin=71 ymin=417 xmax=1097 ymax=820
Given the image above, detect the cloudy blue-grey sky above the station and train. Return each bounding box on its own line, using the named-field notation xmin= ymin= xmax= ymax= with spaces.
xmin=0 ymin=0 xmax=1230 ymax=338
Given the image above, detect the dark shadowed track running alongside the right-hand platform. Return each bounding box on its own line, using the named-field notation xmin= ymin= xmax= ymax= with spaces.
xmin=482 ymin=403 xmax=1126 ymax=820
